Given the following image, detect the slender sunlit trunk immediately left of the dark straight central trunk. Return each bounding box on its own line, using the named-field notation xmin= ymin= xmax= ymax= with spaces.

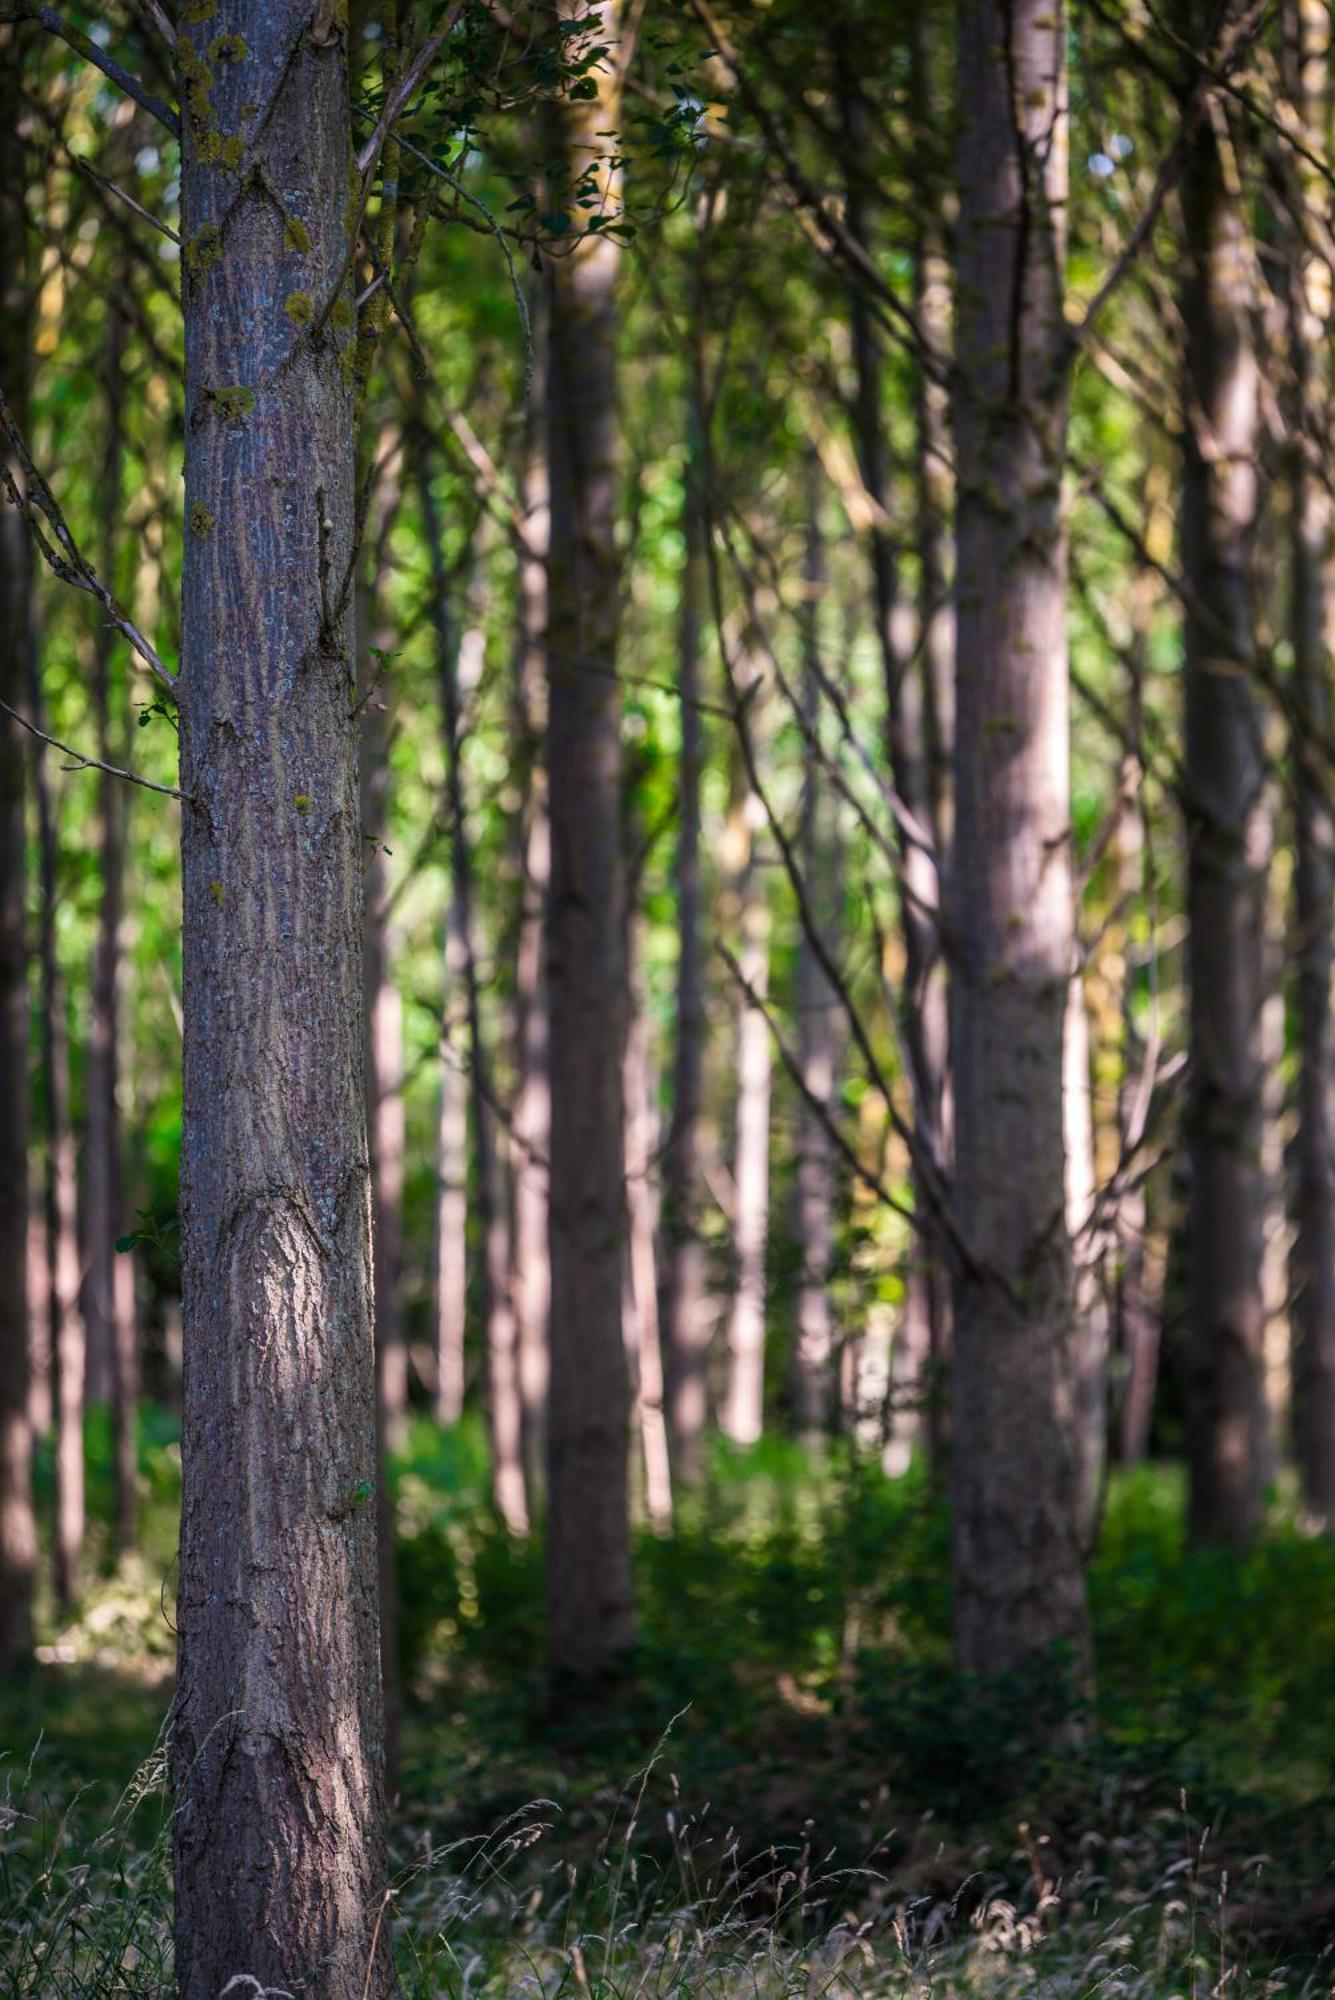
xmin=512 ymin=286 xmax=552 ymax=1506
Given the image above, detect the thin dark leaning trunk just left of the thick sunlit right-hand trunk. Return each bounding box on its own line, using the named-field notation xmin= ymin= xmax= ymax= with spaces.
xmin=837 ymin=36 xmax=949 ymax=1448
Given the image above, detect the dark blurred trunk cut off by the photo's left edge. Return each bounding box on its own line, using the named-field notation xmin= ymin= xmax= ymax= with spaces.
xmin=0 ymin=26 xmax=38 ymax=1668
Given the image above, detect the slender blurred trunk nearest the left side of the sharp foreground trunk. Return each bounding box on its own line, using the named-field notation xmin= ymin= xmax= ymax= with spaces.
xmin=84 ymin=308 xmax=138 ymax=1550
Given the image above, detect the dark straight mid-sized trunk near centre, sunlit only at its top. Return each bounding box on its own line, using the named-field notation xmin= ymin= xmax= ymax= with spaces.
xmin=548 ymin=0 xmax=632 ymax=1684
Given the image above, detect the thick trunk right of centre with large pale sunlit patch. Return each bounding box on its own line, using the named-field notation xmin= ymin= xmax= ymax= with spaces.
xmin=951 ymin=0 xmax=1085 ymax=1674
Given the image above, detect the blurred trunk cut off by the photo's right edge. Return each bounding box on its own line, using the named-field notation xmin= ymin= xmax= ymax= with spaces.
xmin=1289 ymin=0 xmax=1335 ymax=1528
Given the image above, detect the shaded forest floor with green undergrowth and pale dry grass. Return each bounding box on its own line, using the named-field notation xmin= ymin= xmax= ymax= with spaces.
xmin=0 ymin=1410 xmax=1335 ymax=2000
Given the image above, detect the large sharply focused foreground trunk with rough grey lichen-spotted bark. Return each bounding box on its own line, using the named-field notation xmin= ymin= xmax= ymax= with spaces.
xmin=172 ymin=0 xmax=394 ymax=2000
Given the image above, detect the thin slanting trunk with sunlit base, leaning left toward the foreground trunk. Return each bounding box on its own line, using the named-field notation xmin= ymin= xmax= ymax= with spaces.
xmin=416 ymin=428 xmax=530 ymax=1534
